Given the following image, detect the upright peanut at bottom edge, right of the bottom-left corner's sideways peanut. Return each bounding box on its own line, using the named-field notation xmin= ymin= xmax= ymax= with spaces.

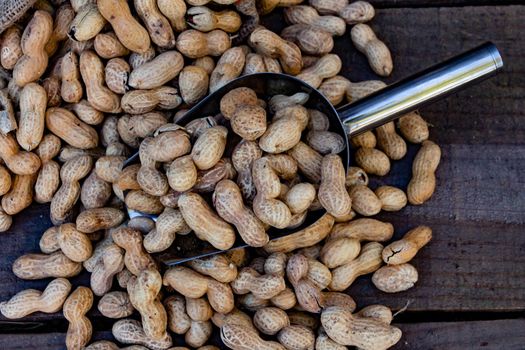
xmin=63 ymin=287 xmax=93 ymax=349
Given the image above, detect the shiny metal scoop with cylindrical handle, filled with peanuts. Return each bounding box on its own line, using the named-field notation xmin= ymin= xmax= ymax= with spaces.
xmin=127 ymin=43 xmax=503 ymax=265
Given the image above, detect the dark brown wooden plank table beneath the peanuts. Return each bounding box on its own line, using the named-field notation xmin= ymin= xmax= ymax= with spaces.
xmin=0 ymin=0 xmax=525 ymax=350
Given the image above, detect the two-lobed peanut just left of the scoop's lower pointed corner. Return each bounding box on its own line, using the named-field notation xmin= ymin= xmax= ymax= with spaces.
xmin=111 ymin=227 xmax=155 ymax=276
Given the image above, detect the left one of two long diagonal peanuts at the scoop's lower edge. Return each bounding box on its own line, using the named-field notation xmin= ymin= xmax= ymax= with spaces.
xmin=179 ymin=192 xmax=235 ymax=250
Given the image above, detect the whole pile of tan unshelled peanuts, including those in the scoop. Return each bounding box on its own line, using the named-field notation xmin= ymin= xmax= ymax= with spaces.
xmin=0 ymin=0 xmax=441 ymax=350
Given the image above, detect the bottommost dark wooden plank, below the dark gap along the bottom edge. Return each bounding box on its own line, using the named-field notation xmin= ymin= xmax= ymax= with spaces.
xmin=0 ymin=319 xmax=525 ymax=350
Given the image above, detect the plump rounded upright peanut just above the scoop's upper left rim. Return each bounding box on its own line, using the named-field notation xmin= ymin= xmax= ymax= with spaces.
xmin=179 ymin=65 xmax=209 ymax=105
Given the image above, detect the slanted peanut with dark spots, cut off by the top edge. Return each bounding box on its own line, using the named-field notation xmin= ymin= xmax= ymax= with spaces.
xmin=133 ymin=0 xmax=175 ymax=49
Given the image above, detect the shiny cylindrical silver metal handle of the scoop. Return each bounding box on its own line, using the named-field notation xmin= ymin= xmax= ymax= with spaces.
xmin=337 ymin=42 xmax=503 ymax=136
